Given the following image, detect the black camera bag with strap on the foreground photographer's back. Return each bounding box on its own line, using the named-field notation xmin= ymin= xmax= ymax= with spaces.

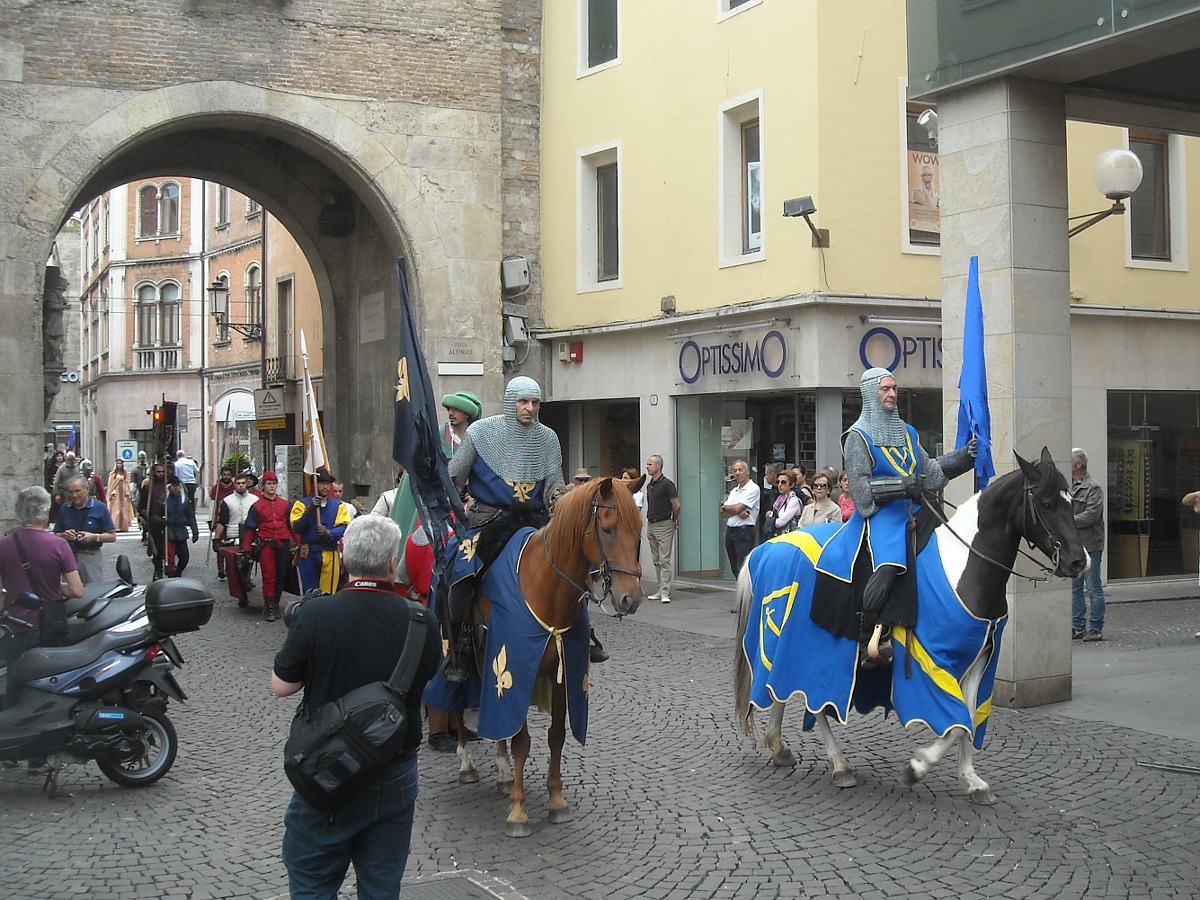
xmin=283 ymin=600 xmax=430 ymax=812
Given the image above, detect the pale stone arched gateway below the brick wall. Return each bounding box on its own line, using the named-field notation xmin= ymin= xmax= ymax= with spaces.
xmin=0 ymin=72 xmax=536 ymax=521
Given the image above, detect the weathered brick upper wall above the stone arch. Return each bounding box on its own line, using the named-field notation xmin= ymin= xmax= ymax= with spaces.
xmin=0 ymin=0 xmax=506 ymax=112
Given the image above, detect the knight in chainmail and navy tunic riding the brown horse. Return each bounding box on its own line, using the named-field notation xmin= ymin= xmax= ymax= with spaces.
xmin=438 ymin=376 xmax=568 ymax=684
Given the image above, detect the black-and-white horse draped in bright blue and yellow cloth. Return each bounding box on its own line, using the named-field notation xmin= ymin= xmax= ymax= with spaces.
xmin=734 ymin=449 xmax=1087 ymax=804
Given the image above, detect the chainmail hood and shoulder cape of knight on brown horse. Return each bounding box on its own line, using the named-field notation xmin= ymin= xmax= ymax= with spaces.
xmin=467 ymin=376 xmax=563 ymax=481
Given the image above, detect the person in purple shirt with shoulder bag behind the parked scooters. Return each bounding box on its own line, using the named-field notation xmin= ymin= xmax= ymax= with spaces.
xmin=0 ymin=485 xmax=83 ymax=706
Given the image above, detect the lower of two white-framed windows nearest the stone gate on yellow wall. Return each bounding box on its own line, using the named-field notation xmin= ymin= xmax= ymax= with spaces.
xmin=578 ymin=145 xmax=622 ymax=290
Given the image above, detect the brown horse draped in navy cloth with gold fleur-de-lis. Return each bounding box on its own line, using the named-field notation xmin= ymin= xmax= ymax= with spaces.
xmin=458 ymin=476 xmax=646 ymax=838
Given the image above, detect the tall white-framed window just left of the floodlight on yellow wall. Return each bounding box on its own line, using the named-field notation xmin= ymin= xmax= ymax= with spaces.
xmin=718 ymin=91 xmax=764 ymax=266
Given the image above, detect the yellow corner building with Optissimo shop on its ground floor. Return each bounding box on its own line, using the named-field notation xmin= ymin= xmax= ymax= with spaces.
xmin=535 ymin=0 xmax=1200 ymax=577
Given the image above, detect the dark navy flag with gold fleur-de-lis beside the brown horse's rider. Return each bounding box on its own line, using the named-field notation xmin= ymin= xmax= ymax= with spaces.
xmin=391 ymin=259 xmax=466 ymax=559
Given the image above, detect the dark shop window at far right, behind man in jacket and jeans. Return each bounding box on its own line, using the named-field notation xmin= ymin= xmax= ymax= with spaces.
xmin=1104 ymin=391 xmax=1200 ymax=578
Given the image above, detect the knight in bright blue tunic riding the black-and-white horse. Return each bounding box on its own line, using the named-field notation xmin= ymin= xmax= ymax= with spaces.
xmin=811 ymin=368 xmax=977 ymax=667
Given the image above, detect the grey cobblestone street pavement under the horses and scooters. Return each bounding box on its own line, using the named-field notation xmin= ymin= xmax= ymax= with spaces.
xmin=0 ymin=541 xmax=1200 ymax=900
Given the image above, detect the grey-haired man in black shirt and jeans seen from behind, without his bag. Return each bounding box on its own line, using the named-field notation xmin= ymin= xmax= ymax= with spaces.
xmin=271 ymin=516 xmax=442 ymax=898
